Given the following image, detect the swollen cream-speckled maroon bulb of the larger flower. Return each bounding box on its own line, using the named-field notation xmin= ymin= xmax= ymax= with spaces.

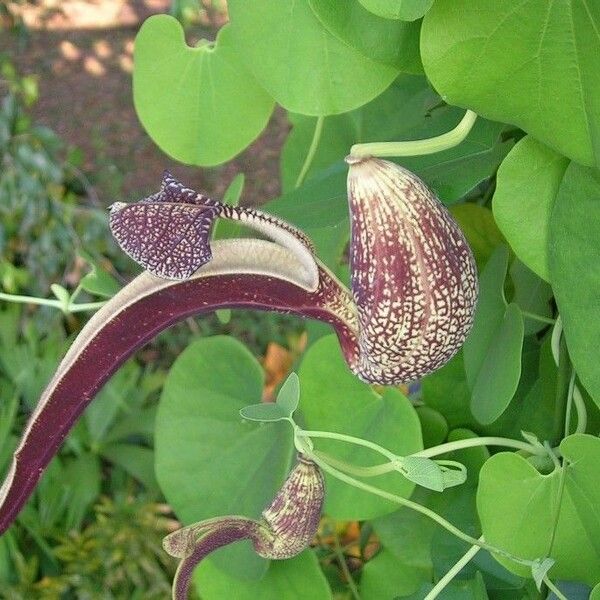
xmin=347 ymin=156 xmax=478 ymax=383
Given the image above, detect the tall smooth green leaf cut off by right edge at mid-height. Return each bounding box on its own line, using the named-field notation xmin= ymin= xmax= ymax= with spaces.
xmin=550 ymin=164 xmax=600 ymax=406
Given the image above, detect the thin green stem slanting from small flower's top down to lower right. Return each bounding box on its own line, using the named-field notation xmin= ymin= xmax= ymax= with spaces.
xmin=304 ymin=452 xmax=533 ymax=568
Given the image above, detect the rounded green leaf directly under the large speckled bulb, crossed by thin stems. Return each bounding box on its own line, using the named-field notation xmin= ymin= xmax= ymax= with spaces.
xmin=299 ymin=336 xmax=423 ymax=520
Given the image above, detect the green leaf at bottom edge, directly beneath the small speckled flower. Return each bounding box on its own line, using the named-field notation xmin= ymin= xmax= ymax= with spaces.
xmin=194 ymin=550 xmax=331 ymax=600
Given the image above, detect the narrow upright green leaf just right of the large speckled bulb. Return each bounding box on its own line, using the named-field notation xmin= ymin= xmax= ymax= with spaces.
xmin=464 ymin=246 xmax=523 ymax=424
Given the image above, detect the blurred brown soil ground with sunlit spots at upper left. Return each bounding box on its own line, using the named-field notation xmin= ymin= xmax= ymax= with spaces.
xmin=0 ymin=0 xmax=289 ymax=205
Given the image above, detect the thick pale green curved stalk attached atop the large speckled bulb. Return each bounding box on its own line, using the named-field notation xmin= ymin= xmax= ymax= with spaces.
xmin=350 ymin=110 xmax=477 ymax=157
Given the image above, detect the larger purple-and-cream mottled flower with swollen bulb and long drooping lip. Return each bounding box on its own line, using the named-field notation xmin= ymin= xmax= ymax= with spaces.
xmin=0 ymin=157 xmax=477 ymax=533
